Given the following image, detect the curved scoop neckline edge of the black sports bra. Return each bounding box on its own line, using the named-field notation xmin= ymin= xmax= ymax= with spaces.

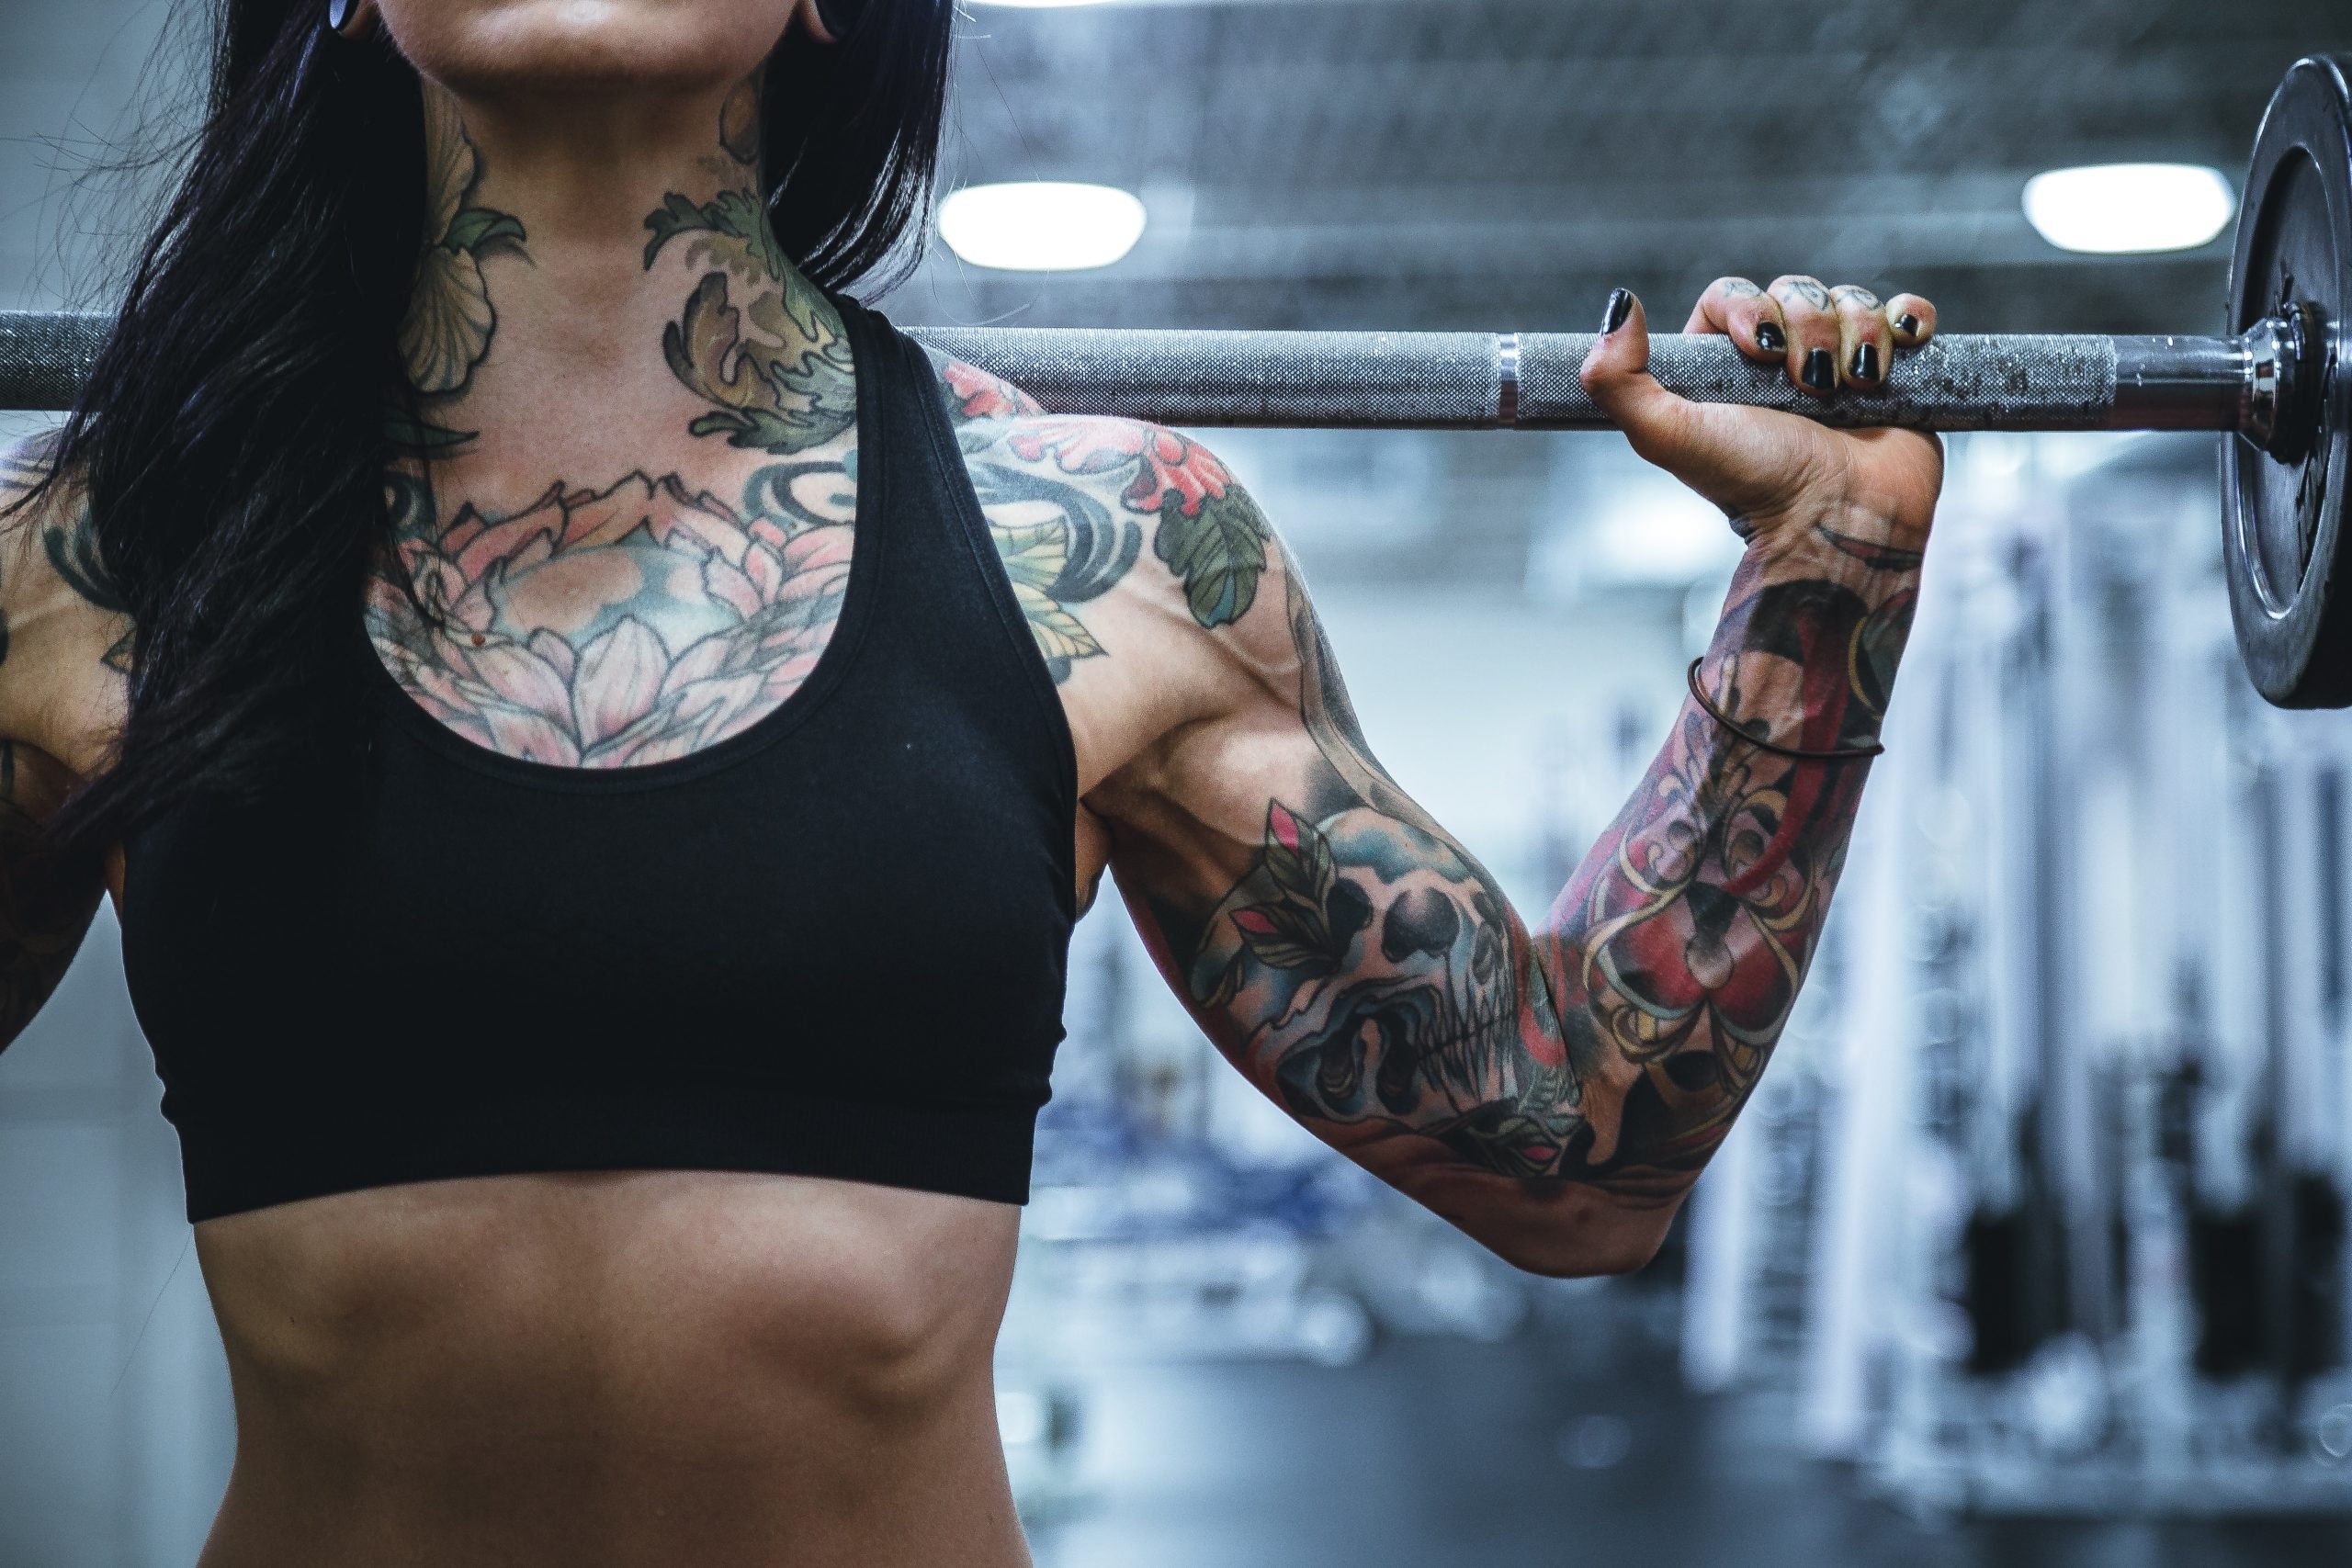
xmin=353 ymin=299 xmax=885 ymax=795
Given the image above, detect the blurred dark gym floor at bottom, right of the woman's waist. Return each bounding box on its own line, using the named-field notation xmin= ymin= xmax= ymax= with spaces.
xmin=1035 ymin=1293 xmax=2352 ymax=1568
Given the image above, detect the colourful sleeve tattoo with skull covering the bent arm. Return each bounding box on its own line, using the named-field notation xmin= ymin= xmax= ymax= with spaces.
xmin=1120 ymin=472 xmax=1919 ymax=1208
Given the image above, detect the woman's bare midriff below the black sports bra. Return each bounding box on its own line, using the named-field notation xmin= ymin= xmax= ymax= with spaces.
xmin=195 ymin=1170 xmax=1028 ymax=1568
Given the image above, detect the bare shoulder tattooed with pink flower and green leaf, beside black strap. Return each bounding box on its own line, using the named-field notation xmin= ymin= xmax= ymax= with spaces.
xmin=933 ymin=357 xmax=1291 ymax=717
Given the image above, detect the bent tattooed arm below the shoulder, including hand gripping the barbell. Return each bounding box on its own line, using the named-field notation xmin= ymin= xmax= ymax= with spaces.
xmin=1068 ymin=280 xmax=1940 ymax=1274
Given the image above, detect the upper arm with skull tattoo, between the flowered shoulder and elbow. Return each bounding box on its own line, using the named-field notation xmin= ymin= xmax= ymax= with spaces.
xmin=1105 ymin=536 xmax=1578 ymax=1185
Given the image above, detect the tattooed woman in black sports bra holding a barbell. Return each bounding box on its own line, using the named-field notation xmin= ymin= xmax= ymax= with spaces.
xmin=0 ymin=0 xmax=1940 ymax=1568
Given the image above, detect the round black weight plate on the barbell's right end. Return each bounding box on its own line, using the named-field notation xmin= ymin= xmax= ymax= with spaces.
xmin=2222 ymin=56 xmax=2352 ymax=707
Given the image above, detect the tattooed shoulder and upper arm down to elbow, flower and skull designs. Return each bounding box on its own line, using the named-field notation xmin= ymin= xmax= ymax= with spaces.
xmin=917 ymin=389 xmax=1636 ymax=1218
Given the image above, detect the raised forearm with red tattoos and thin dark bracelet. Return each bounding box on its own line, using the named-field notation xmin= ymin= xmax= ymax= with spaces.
xmin=1532 ymin=502 xmax=1919 ymax=1206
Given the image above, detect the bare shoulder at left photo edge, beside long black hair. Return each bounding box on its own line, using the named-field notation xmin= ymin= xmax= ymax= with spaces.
xmin=0 ymin=434 xmax=131 ymax=761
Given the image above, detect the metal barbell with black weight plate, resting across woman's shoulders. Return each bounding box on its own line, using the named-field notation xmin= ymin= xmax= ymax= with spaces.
xmin=0 ymin=56 xmax=2352 ymax=707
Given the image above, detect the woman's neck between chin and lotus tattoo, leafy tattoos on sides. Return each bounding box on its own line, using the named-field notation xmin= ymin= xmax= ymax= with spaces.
xmin=400 ymin=83 xmax=854 ymax=502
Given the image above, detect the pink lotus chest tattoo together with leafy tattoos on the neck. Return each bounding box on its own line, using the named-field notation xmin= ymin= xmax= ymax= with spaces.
xmin=367 ymin=73 xmax=856 ymax=769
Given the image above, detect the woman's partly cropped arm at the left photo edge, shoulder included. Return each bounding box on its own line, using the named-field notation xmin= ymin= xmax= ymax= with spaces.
xmin=0 ymin=445 xmax=127 ymax=1048
